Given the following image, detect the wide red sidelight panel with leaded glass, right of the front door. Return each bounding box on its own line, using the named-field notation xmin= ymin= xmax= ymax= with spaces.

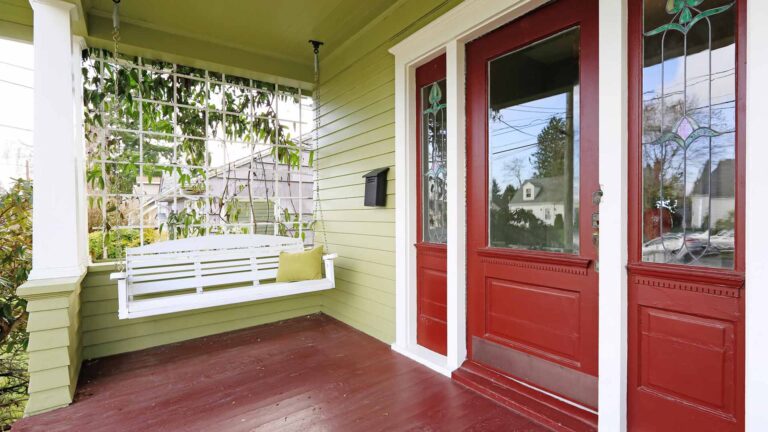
xmin=627 ymin=0 xmax=746 ymax=432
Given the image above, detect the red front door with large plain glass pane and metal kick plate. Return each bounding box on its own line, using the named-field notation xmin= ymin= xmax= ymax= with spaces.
xmin=463 ymin=0 xmax=599 ymax=422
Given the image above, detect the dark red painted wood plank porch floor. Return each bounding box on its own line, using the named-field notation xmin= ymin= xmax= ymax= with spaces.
xmin=13 ymin=315 xmax=547 ymax=432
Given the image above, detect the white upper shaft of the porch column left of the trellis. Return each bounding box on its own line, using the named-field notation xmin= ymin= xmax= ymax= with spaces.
xmin=30 ymin=0 xmax=87 ymax=280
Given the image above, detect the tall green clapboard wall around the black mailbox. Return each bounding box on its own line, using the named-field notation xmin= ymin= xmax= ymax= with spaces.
xmin=318 ymin=0 xmax=460 ymax=343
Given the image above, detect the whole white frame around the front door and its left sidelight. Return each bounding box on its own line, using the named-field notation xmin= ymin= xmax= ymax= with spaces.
xmin=390 ymin=0 xmax=628 ymax=431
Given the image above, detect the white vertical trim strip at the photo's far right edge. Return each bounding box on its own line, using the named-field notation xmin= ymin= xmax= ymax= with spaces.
xmin=745 ymin=0 xmax=768 ymax=432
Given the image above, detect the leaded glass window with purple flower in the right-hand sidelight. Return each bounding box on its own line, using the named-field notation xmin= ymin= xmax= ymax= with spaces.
xmin=642 ymin=0 xmax=736 ymax=269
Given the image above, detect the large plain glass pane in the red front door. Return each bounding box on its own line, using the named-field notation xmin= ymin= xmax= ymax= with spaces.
xmin=488 ymin=29 xmax=579 ymax=253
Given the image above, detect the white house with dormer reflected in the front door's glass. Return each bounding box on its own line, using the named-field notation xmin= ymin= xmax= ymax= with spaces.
xmin=509 ymin=177 xmax=564 ymax=225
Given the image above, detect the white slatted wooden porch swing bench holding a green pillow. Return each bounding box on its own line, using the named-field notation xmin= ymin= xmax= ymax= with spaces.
xmin=110 ymin=234 xmax=337 ymax=319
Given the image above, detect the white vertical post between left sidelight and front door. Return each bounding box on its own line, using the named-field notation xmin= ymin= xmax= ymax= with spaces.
xmin=445 ymin=40 xmax=467 ymax=370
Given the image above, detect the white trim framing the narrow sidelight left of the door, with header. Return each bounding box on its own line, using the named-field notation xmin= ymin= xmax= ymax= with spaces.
xmin=390 ymin=0 xmax=546 ymax=380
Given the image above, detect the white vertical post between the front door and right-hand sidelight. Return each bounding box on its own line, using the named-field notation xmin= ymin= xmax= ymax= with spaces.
xmin=598 ymin=0 xmax=628 ymax=432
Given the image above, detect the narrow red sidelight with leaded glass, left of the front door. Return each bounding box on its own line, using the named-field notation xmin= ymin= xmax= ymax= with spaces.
xmin=415 ymin=55 xmax=448 ymax=355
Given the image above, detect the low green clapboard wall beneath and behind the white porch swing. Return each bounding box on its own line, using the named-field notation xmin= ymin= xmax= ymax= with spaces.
xmin=80 ymin=263 xmax=322 ymax=359
